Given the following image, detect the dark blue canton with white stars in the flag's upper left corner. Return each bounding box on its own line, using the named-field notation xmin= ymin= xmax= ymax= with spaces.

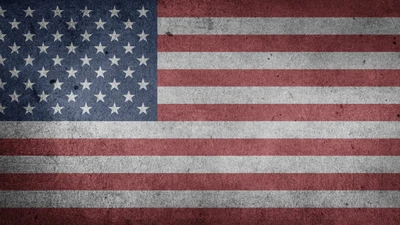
xmin=0 ymin=0 xmax=157 ymax=121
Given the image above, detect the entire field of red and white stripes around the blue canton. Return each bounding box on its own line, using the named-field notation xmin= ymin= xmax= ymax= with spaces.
xmin=0 ymin=0 xmax=400 ymax=225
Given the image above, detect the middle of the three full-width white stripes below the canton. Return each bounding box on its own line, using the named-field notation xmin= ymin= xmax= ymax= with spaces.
xmin=0 ymin=156 xmax=400 ymax=173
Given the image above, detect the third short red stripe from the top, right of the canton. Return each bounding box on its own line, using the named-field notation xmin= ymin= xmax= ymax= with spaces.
xmin=158 ymin=70 xmax=400 ymax=86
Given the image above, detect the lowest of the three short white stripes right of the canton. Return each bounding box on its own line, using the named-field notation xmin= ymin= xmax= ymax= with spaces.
xmin=158 ymin=87 xmax=400 ymax=104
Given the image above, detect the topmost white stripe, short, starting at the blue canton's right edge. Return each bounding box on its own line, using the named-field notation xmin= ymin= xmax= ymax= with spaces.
xmin=157 ymin=17 xmax=400 ymax=35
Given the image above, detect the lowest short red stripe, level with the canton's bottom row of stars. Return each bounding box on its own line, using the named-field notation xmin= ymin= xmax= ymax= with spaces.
xmin=158 ymin=104 xmax=400 ymax=121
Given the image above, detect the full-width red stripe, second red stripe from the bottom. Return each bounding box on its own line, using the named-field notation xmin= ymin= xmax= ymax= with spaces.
xmin=0 ymin=173 xmax=400 ymax=190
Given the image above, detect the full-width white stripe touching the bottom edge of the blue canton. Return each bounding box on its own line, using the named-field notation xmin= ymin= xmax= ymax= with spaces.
xmin=0 ymin=121 xmax=400 ymax=138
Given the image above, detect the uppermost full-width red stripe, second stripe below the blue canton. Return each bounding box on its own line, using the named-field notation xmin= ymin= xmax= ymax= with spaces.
xmin=0 ymin=139 xmax=400 ymax=156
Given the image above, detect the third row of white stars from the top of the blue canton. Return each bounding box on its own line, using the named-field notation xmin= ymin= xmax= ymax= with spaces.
xmin=0 ymin=30 xmax=149 ymax=42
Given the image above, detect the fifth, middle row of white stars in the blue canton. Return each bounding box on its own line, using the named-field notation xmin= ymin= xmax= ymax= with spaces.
xmin=0 ymin=54 xmax=149 ymax=67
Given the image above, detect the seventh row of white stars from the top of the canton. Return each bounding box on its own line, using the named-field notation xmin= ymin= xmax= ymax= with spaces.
xmin=0 ymin=78 xmax=150 ymax=91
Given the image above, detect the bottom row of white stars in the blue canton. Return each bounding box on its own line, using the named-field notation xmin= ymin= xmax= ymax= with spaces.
xmin=0 ymin=103 xmax=149 ymax=115
